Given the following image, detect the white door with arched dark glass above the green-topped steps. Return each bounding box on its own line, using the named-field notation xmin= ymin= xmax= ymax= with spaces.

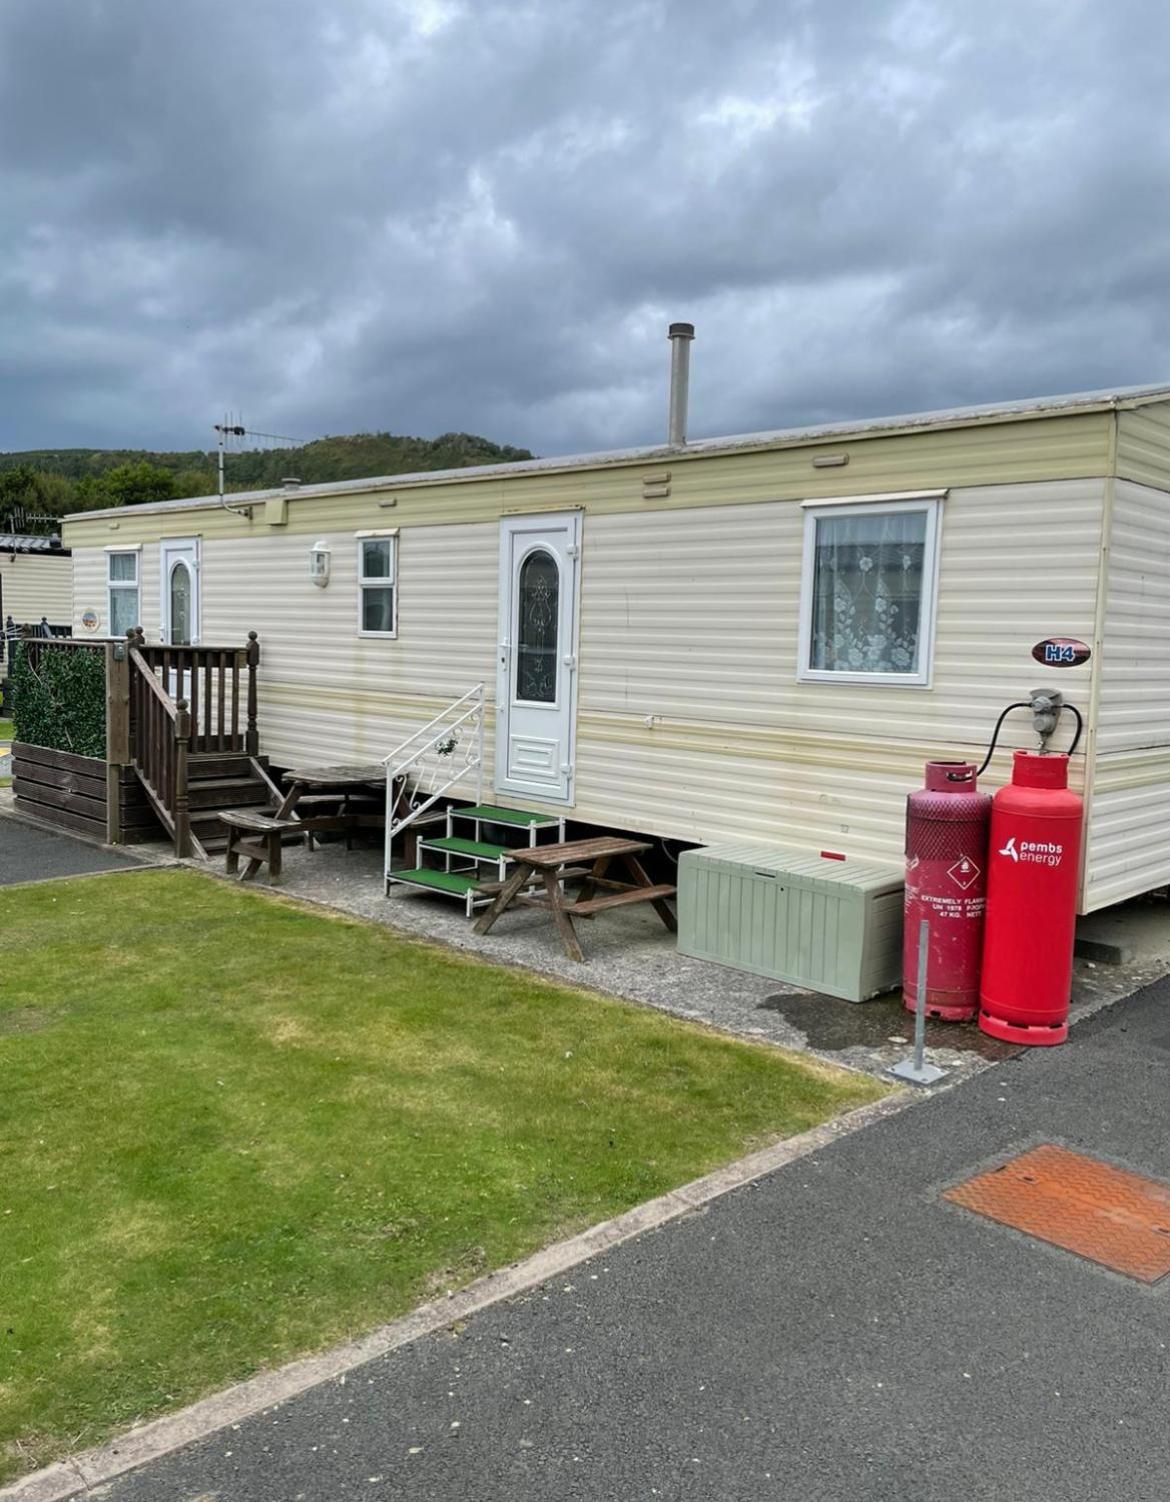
xmin=496 ymin=511 xmax=581 ymax=804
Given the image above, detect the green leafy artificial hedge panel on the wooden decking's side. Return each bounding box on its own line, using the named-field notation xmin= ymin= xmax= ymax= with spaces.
xmin=12 ymin=643 xmax=105 ymax=757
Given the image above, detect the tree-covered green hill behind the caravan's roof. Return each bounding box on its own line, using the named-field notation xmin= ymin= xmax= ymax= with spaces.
xmin=0 ymin=433 xmax=532 ymax=530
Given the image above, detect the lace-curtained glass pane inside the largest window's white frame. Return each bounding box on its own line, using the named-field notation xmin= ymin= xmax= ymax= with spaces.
xmin=808 ymin=511 xmax=927 ymax=673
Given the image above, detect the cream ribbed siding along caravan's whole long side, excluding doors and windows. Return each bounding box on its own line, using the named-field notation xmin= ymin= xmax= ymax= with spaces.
xmin=75 ymin=481 xmax=1104 ymax=883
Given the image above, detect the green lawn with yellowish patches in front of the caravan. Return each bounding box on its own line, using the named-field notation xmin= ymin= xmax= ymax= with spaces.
xmin=0 ymin=871 xmax=883 ymax=1482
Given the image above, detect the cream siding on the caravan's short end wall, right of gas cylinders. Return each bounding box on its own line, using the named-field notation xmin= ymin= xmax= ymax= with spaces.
xmin=1084 ymin=477 xmax=1170 ymax=907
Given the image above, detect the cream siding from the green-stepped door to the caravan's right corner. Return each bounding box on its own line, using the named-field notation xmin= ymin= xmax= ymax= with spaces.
xmin=574 ymin=479 xmax=1104 ymax=859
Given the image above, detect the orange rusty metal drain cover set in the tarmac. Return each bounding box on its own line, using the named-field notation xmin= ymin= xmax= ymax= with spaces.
xmin=943 ymin=1143 xmax=1170 ymax=1283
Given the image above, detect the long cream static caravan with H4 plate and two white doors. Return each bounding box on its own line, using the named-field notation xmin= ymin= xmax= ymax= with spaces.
xmin=65 ymin=386 xmax=1170 ymax=912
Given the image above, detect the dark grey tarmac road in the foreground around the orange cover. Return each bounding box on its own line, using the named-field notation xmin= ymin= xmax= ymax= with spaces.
xmin=101 ymin=981 xmax=1170 ymax=1502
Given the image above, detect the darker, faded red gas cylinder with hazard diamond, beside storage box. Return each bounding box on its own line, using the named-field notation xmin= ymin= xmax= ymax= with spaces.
xmin=903 ymin=762 xmax=991 ymax=1023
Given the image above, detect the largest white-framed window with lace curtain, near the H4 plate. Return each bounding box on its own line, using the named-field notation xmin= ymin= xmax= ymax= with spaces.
xmin=798 ymin=491 xmax=943 ymax=688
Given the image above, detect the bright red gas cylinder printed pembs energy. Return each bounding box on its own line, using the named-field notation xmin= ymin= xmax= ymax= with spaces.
xmin=979 ymin=751 xmax=1084 ymax=1044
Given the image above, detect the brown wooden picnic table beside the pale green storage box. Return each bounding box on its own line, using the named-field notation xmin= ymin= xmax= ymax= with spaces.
xmin=475 ymin=835 xmax=677 ymax=961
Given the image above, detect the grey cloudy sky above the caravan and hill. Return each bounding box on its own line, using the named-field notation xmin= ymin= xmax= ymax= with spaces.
xmin=0 ymin=0 xmax=1170 ymax=454
